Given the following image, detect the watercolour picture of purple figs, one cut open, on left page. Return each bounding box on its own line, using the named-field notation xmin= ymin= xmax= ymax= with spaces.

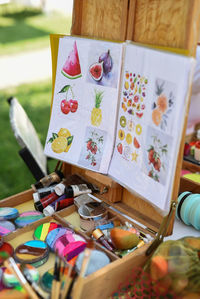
xmin=86 ymin=43 xmax=120 ymax=87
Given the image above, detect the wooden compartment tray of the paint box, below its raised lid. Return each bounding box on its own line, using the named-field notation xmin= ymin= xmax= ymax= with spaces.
xmin=0 ymin=172 xmax=167 ymax=298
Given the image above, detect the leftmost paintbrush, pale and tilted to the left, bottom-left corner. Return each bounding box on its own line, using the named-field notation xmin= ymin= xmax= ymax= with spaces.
xmin=4 ymin=257 xmax=39 ymax=299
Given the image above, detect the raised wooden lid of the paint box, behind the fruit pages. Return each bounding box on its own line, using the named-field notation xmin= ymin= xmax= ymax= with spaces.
xmin=52 ymin=0 xmax=200 ymax=234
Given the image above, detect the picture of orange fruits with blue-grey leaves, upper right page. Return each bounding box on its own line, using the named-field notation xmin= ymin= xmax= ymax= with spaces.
xmin=152 ymin=79 xmax=176 ymax=131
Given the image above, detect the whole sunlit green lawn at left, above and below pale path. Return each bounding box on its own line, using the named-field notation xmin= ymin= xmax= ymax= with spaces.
xmin=0 ymin=4 xmax=71 ymax=199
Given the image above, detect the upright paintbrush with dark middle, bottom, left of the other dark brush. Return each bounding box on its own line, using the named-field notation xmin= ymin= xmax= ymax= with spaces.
xmin=51 ymin=252 xmax=61 ymax=299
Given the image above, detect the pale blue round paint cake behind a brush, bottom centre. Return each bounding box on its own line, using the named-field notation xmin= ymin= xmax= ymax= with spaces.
xmin=76 ymin=250 xmax=110 ymax=276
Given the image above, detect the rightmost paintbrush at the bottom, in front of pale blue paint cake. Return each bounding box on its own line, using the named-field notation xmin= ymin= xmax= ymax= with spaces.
xmin=67 ymin=240 xmax=95 ymax=299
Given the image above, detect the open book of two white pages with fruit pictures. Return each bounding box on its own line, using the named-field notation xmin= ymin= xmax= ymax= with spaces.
xmin=45 ymin=36 xmax=194 ymax=211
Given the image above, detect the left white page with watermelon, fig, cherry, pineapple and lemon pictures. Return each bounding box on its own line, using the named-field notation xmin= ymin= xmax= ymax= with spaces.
xmin=45 ymin=37 xmax=122 ymax=173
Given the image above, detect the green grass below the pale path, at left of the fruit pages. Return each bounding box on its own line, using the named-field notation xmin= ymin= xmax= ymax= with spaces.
xmin=0 ymin=81 xmax=56 ymax=199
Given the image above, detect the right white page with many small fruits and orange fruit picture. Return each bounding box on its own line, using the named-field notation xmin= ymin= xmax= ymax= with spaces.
xmin=109 ymin=44 xmax=194 ymax=211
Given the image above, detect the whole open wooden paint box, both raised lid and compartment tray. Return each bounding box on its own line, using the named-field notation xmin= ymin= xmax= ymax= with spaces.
xmin=0 ymin=0 xmax=200 ymax=299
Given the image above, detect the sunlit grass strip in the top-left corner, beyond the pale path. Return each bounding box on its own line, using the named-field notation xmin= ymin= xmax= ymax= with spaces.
xmin=0 ymin=4 xmax=71 ymax=55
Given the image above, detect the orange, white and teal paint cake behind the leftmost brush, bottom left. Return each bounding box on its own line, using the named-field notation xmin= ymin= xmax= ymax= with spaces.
xmin=3 ymin=264 xmax=40 ymax=287
